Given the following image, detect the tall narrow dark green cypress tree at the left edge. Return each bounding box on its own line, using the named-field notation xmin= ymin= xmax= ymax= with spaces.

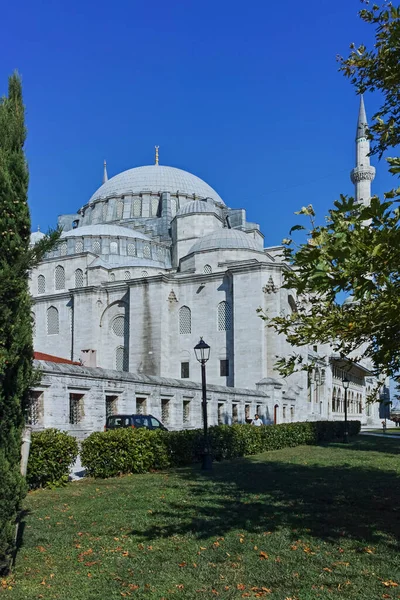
xmin=0 ymin=73 xmax=59 ymax=569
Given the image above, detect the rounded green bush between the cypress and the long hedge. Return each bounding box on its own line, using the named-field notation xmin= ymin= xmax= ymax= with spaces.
xmin=26 ymin=429 xmax=78 ymax=489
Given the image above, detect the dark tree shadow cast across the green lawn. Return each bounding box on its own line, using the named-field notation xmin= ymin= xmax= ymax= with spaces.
xmin=131 ymin=440 xmax=400 ymax=548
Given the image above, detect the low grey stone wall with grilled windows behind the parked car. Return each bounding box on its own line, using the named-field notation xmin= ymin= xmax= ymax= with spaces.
xmin=31 ymin=361 xmax=273 ymax=439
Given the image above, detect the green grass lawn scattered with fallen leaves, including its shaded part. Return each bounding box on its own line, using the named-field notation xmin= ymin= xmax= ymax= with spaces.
xmin=0 ymin=437 xmax=400 ymax=600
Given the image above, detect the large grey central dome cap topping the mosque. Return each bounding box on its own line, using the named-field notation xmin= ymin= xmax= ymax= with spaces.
xmin=90 ymin=165 xmax=224 ymax=204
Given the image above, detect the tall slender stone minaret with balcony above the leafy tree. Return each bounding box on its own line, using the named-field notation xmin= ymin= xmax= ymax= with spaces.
xmin=350 ymin=96 xmax=375 ymax=206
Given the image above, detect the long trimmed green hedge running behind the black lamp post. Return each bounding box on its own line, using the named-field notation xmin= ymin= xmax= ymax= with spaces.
xmin=81 ymin=421 xmax=361 ymax=477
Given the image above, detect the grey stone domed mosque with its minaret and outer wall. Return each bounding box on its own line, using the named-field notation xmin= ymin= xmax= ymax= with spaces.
xmin=31 ymin=98 xmax=379 ymax=438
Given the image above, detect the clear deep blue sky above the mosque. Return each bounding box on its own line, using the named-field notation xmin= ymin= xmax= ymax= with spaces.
xmin=0 ymin=0 xmax=392 ymax=245
